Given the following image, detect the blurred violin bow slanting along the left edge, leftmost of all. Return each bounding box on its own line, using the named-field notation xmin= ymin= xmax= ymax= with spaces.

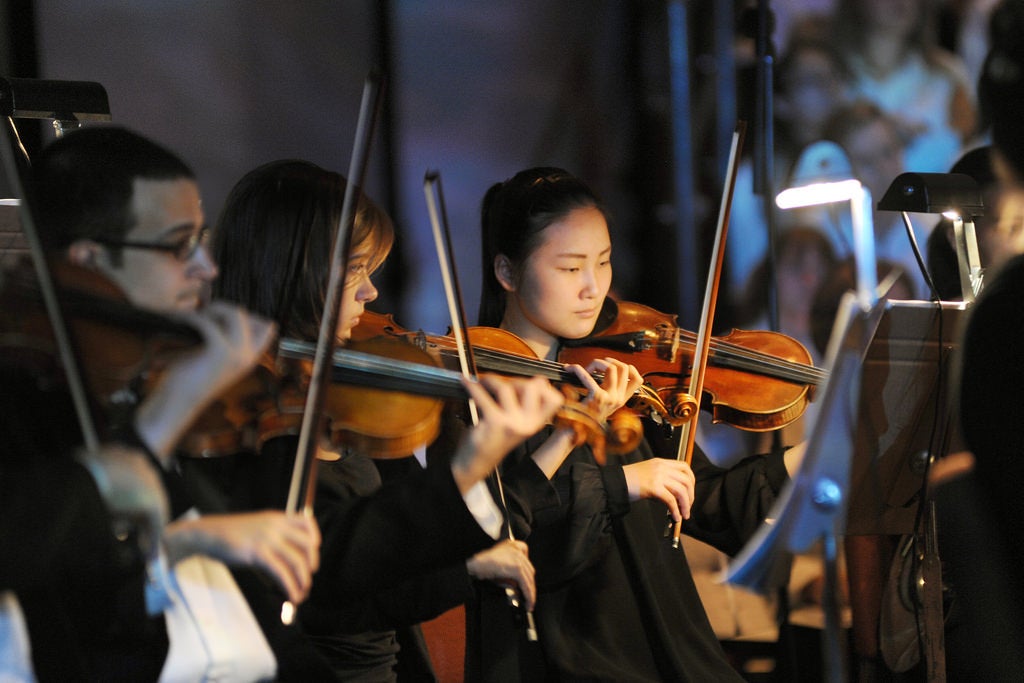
xmin=0 ymin=109 xmax=170 ymax=615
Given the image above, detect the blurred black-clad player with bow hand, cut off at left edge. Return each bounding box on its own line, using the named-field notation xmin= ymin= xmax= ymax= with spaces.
xmin=0 ymin=370 xmax=167 ymax=681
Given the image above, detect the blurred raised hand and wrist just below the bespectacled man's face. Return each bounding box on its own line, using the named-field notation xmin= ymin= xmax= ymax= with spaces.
xmin=135 ymin=301 xmax=275 ymax=467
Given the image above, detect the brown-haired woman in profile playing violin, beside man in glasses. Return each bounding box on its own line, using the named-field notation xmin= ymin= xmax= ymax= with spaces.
xmin=206 ymin=161 xmax=562 ymax=681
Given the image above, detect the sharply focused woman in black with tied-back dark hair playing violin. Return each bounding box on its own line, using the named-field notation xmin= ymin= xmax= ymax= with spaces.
xmin=472 ymin=168 xmax=787 ymax=681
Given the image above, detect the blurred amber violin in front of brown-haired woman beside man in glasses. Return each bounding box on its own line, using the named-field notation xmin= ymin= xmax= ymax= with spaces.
xmin=179 ymin=336 xmax=614 ymax=459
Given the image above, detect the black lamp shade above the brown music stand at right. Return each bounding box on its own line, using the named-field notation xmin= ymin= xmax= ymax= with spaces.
xmin=879 ymin=173 xmax=985 ymax=216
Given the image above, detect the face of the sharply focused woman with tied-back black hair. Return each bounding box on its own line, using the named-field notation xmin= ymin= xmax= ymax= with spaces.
xmin=496 ymin=207 xmax=611 ymax=358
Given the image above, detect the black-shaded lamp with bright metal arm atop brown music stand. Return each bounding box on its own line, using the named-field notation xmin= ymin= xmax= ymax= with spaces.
xmin=879 ymin=173 xmax=985 ymax=303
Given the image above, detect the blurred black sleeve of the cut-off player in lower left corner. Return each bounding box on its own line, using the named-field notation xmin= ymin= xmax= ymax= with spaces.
xmin=0 ymin=456 xmax=167 ymax=680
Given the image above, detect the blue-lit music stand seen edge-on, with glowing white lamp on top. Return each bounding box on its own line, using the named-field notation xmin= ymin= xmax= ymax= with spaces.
xmin=724 ymin=172 xmax=883 ymax=681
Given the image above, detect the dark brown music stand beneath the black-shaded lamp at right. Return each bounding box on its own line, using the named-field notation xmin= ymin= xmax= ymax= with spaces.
xmin=847 ymin=301 xmax=970 ymax=680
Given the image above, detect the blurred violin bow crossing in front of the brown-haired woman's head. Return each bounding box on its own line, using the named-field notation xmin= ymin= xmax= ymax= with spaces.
xmin=282 ymin=70 xmax=381 ymax=518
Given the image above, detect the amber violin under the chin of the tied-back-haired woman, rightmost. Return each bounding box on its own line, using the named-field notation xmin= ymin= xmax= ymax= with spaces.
xmin=558 ymin=299 xmax=827 ymax=432
